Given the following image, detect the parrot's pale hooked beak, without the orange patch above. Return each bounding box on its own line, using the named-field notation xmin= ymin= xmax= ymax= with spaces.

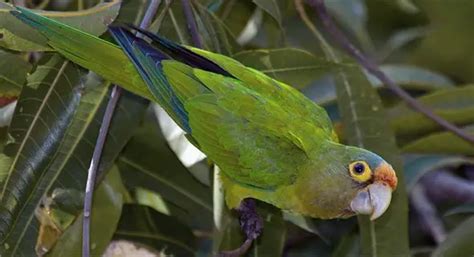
xmin=351 ymin=183 xmax=392 ymax=220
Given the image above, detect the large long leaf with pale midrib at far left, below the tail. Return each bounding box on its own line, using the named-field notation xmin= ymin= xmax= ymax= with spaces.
xmin=0 ymin=55 xmax=84 ymax=256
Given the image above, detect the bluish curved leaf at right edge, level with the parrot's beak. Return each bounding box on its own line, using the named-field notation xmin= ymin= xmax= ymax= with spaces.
xmin=403 ymin=155 xmax=474 ymax=192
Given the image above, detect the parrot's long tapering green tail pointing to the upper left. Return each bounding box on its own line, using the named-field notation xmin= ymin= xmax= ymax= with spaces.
xmin=11 ymin=7 xmax=154 ymax=100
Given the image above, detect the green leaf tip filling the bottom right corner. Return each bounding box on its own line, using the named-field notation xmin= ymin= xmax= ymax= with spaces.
xmin=431 ymin=217 xmax=474 ymax=257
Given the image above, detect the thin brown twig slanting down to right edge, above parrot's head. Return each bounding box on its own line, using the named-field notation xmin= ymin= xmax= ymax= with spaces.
xmin=307 ymin=0 xmax=474 ymax=144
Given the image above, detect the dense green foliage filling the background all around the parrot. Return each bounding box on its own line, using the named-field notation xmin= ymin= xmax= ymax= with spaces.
xmin=0 ymin=0 xmax=474 ymax=257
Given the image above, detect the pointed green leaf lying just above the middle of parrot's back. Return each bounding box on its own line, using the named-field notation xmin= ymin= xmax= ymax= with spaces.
xmin=233 ymin=48 xmax=335 ymax=89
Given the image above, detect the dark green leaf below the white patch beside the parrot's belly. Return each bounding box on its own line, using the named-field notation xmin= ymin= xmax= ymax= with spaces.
xmin=118 ymin=120 xmax=213 ymax=229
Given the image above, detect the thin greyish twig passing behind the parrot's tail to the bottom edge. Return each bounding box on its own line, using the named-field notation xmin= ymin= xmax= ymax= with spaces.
xmin=82 ymin=0 xmax=161 ymax=257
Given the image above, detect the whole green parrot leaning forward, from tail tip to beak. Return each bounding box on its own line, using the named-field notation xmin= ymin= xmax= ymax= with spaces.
xmin=12 ymin=8 xmax=397 ymax=255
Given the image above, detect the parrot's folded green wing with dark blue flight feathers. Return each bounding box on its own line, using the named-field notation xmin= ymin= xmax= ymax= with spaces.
xmin=110 ymin=27 xmax=332 ymax=189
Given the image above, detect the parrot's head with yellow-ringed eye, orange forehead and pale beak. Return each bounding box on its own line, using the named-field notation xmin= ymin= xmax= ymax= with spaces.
xmin=298 ymin=144 xmax=397 ymax=220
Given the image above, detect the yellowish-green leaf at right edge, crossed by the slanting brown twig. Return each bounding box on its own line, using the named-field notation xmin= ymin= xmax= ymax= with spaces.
xmin=389 ymin=85 xmax=474 ymax=136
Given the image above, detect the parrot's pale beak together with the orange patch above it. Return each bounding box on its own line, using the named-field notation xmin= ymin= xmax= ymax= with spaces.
xmin=351 ymin=162 xmax=397 ymax=220
